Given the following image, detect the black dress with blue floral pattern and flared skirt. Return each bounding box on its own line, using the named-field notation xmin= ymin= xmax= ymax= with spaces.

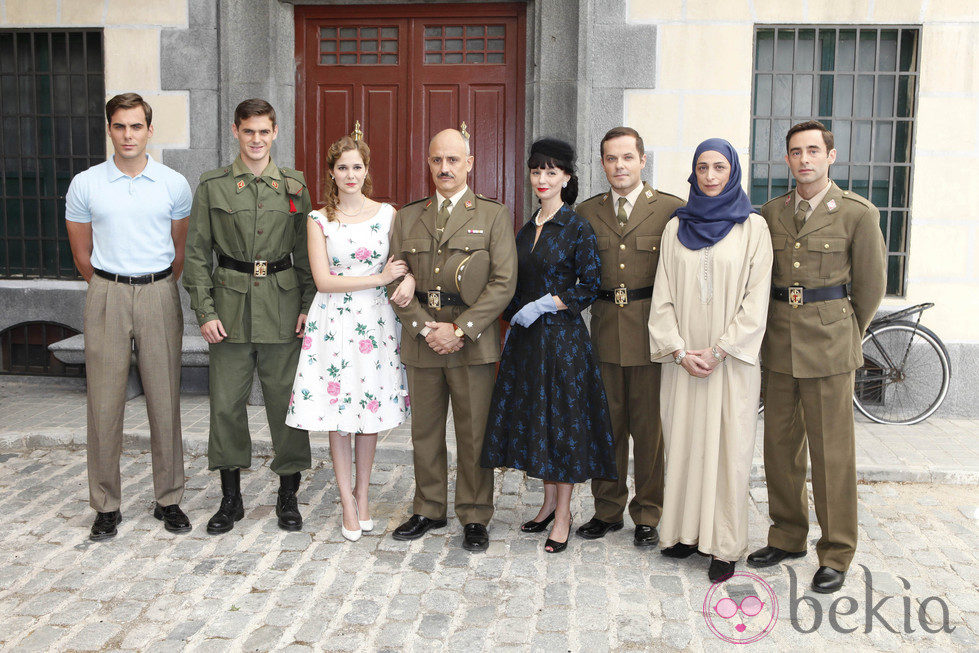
xmin=481 ymin=206 xmax=616 ymax=483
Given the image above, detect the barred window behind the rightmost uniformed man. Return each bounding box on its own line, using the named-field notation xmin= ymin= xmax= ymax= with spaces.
xmin=751 ymin=26 xmax=920 ymax=295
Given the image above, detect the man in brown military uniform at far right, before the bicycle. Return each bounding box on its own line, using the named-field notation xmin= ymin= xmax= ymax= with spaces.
xmin=748 ymin=121 xmax=887 ymax=593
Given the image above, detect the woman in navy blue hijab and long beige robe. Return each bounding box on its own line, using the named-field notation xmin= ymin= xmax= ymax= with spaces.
xmin=649 ymin=138 xmax=772 ymax=583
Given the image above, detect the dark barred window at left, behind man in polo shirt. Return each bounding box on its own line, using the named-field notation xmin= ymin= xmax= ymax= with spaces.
xmin=0 ymin=29 xmax=105 ymax=279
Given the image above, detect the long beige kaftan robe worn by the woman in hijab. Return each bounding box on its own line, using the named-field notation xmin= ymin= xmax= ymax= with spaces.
xmin=649 ymin=214 xmax=772 ymax=561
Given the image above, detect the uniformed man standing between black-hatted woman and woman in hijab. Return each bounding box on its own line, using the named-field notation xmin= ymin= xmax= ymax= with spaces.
xmin=577 ymin=127 xmax=684 ymax=546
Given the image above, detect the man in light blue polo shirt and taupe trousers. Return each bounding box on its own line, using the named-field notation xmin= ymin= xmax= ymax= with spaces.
xmin=65 ymin=93 xmax=191 ymax=541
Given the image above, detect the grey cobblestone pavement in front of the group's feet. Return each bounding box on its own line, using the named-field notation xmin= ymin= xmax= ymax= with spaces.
xmin=0 ymin=448 xmax=979 ymax=651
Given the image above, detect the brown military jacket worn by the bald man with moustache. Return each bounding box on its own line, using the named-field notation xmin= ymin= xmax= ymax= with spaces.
xmin=389 ymin=188 xmax=517 ymax=367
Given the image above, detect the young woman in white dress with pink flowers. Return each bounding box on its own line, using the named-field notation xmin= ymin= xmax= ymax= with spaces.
xmin=286 ymin=136 xmax=414 ymax=541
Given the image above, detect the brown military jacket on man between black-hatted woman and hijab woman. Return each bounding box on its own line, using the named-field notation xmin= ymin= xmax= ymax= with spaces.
xmin=576 ymin=184 xmax=685 ymax=366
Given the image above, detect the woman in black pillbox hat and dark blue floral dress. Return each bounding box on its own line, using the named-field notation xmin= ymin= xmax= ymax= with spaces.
xmin=482 ymin=139 xmax=616 ymax=553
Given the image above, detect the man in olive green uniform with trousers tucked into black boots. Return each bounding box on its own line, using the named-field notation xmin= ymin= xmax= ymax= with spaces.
xmin=184 ymin=100 xmax=315 ymax=533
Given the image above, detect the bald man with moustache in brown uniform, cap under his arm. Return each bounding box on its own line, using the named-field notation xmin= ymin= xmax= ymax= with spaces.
xmin=389 ymin=129 xmax=517 ymax=551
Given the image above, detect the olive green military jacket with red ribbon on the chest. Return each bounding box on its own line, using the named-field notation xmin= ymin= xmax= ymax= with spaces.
xmin=183 ymin=156 xmax=316 ymax=343
